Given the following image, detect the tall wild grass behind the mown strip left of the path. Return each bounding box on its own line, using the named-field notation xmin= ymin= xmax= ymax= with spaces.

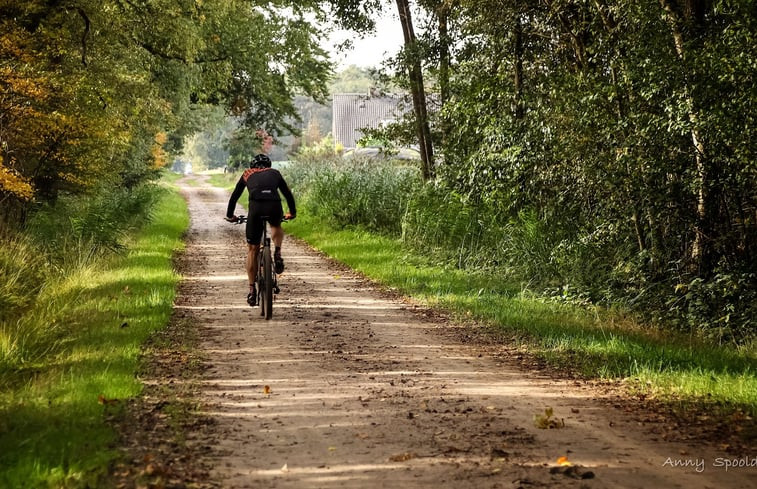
xmin=0 ymin=185 xmax=164 ymax=374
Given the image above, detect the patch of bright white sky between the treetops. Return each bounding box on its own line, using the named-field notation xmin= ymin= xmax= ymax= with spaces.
xmin=325 ymin=11 xmax=403 ymax=70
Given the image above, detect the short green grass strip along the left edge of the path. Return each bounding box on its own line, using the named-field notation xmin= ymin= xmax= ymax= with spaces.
xmin=0 ymin=188 xmax=188 ymax=488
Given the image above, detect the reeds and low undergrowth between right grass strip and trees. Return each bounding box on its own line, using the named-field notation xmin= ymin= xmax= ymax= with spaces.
xmin=287 ymin=158 xmax=757 ymax=344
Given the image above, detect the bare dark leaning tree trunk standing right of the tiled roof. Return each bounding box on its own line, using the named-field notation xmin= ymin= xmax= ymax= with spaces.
xmin=397 ymin=0 xmax=434 ymax=180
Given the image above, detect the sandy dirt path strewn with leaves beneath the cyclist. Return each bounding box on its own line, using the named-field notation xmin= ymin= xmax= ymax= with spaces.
xmin=164 ymin=177 xmax=757 ymax=489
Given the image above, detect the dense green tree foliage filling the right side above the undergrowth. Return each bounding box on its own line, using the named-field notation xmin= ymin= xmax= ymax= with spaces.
xmin=370 ymin=0 xmax=757 ymax=344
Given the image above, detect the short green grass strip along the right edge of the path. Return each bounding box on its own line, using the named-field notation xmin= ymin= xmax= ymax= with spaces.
xmin=287 ymin=213 xmax=757 ymax=416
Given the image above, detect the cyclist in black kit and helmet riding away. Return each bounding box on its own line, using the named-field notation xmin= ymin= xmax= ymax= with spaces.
xmin=226 ymin=154 xmax=297 ymax=306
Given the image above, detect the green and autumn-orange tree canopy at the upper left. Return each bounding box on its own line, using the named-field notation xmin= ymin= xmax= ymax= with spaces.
xmin=0 ymin=0 xmax=330 ymax=223
